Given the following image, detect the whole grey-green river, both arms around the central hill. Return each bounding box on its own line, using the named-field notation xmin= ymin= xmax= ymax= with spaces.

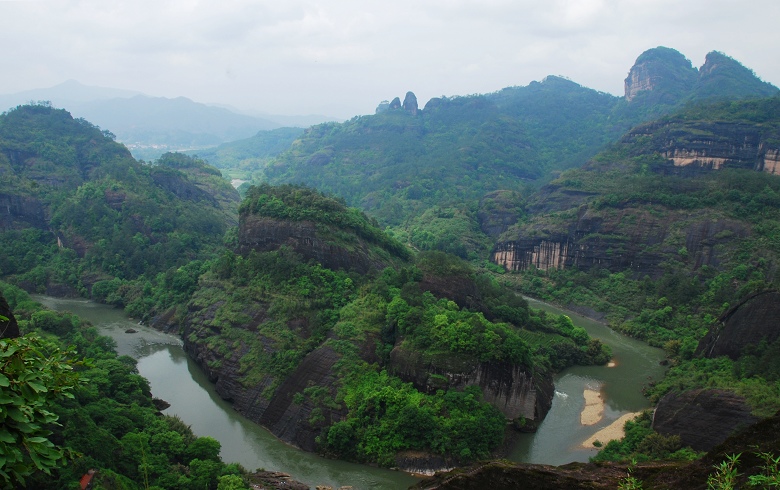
xmin=35 ymin=296 xmax=663 ymax=490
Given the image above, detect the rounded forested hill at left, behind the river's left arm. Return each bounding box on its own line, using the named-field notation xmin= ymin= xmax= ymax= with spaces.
xmin=0 ymin=105 xmax=239 ymax=302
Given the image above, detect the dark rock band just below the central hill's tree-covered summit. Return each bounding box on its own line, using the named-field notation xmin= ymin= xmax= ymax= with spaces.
xmin=238 ymin=214 xmax=386 ymax=274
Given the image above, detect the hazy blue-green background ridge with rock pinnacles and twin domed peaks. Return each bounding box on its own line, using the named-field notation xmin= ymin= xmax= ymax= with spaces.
xmin=195 ymin=47 xmax=778 ymax=259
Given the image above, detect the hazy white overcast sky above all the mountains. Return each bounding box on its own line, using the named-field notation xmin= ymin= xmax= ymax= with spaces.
xmin=0 ymin=0 xmax=780 ymax=118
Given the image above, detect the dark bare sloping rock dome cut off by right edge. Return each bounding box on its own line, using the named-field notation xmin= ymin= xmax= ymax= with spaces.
xmin=696 ymin=291 xmax=780 ymax=359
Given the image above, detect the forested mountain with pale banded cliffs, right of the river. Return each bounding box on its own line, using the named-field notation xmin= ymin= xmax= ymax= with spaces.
xmin=493 ymin=97 xmax=780 ymax=470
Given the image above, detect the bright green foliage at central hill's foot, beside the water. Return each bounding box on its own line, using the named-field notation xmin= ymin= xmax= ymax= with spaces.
xmin=321 ymin=368 xmax=506 ymax=466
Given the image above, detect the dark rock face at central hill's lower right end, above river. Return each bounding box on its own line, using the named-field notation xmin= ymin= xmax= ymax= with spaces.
xmin=390 ymin=345 xmax=555 ymax=424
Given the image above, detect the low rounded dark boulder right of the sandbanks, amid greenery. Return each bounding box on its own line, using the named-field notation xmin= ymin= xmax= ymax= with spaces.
xmin=653 ymin=390 xmax=759 ymax=451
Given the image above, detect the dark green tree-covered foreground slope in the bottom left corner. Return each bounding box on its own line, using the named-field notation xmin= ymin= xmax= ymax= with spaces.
xmin=0 ymin=283 xmax=248 ymax=489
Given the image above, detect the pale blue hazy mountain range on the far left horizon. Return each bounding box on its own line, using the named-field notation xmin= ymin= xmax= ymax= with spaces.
xmin=0 ymin=80 xmax=334 ymax=159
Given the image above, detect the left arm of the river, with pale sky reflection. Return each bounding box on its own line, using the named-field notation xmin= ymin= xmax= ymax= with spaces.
xmin=34 ymin=296 xmax=419 ymax=490
